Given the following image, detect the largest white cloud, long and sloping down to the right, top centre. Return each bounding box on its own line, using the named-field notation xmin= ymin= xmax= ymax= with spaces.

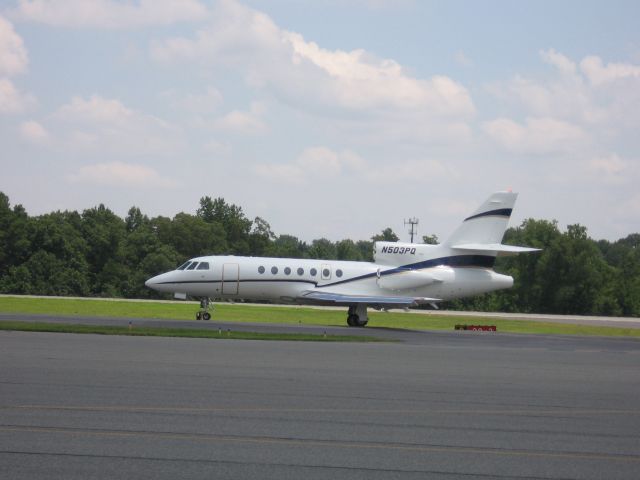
xmin=152 ymin=0 xmax=475 ymax=118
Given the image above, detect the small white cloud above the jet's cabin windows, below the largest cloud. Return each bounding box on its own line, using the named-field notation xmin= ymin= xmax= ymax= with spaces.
xmin=254 ymin=147 xmax=366 ymax=183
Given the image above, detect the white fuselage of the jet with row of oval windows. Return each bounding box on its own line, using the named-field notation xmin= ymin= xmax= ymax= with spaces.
xmin=147 ymin=245 xmax=513 ymax=303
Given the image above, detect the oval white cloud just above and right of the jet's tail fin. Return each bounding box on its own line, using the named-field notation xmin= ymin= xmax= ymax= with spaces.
xmin=483 ymin=117 xmax=588 ymax=154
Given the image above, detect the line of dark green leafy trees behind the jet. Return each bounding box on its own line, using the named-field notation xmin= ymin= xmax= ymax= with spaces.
xmin=0 ymin=192 xmax=640 ymax=316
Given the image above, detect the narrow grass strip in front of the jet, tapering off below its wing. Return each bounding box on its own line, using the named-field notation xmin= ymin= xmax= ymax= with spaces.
xmin=0 ymin=320 xmax=387 ymax=342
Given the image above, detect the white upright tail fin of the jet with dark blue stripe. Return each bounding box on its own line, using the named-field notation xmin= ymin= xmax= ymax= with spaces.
xmin=444 ymin=192 xmax=518 ymax=250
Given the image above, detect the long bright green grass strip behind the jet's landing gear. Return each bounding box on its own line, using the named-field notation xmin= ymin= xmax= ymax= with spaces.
xmin=0 ymin=297 xmax=640 ymax=337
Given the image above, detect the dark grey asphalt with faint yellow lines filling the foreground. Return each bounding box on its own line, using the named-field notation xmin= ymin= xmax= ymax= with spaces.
xmin=0 ymin=324 xmax=640 ymax=480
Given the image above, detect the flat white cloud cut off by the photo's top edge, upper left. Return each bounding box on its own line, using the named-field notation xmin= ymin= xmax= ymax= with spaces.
xmin=12 ymin=0 xmax=208 ymax=28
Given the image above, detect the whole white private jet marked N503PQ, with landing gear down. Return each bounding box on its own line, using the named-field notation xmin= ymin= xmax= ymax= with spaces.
xmin=145 ymin=192 xmax=538 ymax=327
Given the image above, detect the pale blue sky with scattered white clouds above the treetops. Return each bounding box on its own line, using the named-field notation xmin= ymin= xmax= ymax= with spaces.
xmin=0 ymin=0 xmax=640 ymax=240
